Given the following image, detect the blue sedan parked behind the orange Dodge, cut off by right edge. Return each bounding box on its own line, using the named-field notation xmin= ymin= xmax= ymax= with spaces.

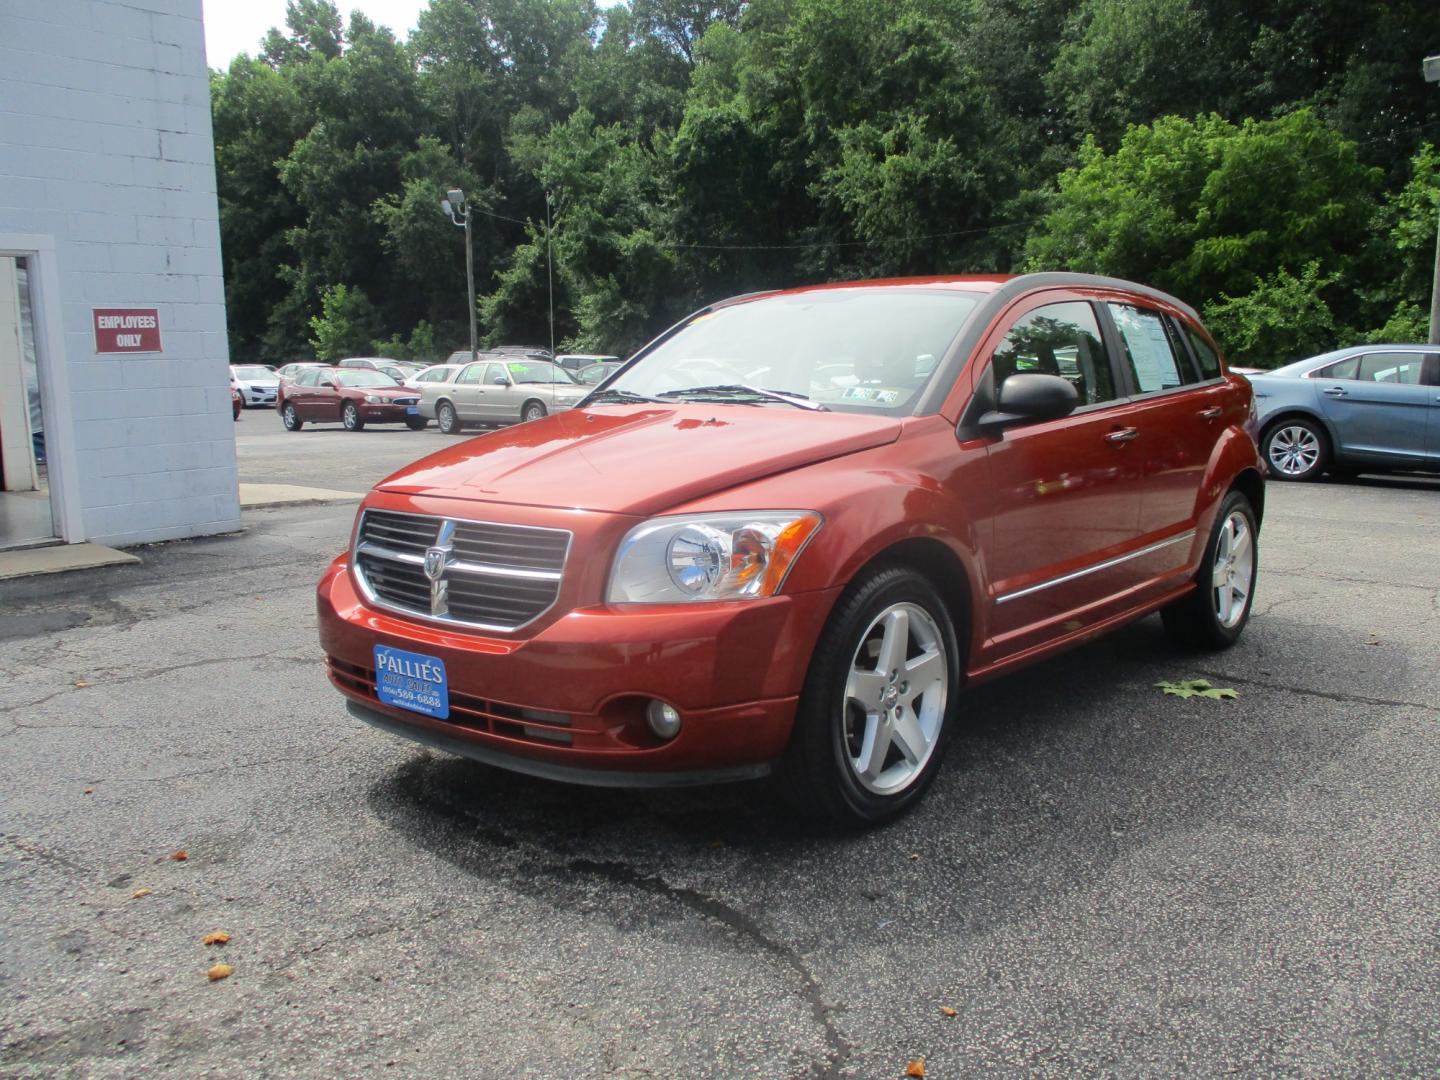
xmin=1247 ymin=346 xmax=1440 ymax=480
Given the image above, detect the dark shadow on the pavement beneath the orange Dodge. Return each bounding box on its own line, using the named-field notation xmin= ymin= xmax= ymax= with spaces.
xmin=369 ymin=618 xmax=1369 ymax=933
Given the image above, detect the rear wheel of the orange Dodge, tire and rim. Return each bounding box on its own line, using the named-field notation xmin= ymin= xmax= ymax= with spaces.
xmin=1161 ymin=491 xmax=1260 ymax=652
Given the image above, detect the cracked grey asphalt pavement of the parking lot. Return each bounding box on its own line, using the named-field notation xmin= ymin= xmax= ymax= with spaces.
xmin=0 ymin=420 xmax=1440 ymax=1079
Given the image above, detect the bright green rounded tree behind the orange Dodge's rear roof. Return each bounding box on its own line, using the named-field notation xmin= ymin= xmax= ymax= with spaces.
xmin=1025 ymin=109 xmax=1380 ymax=312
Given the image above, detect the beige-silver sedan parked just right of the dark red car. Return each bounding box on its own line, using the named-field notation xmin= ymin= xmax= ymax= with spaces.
xmin=420 ymin=359 xmax=590 ymax=435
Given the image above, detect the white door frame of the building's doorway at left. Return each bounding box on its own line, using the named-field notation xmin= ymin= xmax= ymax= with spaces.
xmin=0 ymin=233 xmax=85 ymax=544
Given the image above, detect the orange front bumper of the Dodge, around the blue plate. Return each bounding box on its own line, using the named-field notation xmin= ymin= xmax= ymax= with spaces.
xmin=317 ymin=556 xmax=838 ymax=786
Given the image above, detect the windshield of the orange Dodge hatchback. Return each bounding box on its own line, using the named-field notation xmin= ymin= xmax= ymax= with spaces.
xmin=606 ymin=285 xmax=979 ymax=416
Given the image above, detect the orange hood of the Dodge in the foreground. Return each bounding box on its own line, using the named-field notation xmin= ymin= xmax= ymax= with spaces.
xmin=377 ymin=403 xmax=901 ymax=516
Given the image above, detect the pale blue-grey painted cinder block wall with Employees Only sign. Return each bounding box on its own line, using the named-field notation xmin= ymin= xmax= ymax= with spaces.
xmin=0 ymin=0 xmax=239 ymax=544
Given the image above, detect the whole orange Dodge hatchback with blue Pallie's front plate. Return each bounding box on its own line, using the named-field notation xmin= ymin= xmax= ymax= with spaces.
xmin=318 ymin=274 xmax=1264 ymax=825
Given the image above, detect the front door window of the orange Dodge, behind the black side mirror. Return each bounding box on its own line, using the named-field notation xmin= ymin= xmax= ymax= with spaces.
xmin=991 ymin=301 xmax=1115 ymax=405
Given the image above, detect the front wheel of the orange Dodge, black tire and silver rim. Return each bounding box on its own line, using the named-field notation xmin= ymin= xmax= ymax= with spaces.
xmin=780 ymin=566 xmax=962 ymax=828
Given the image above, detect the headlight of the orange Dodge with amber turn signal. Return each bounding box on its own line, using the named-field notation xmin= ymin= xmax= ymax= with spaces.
xmin=605 ymin=510 xmax=821 ymax=603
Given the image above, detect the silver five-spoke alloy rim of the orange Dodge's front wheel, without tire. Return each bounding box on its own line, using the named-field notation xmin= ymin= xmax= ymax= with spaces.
xmin=844 ymin=603 xmax=950 ymax=795
